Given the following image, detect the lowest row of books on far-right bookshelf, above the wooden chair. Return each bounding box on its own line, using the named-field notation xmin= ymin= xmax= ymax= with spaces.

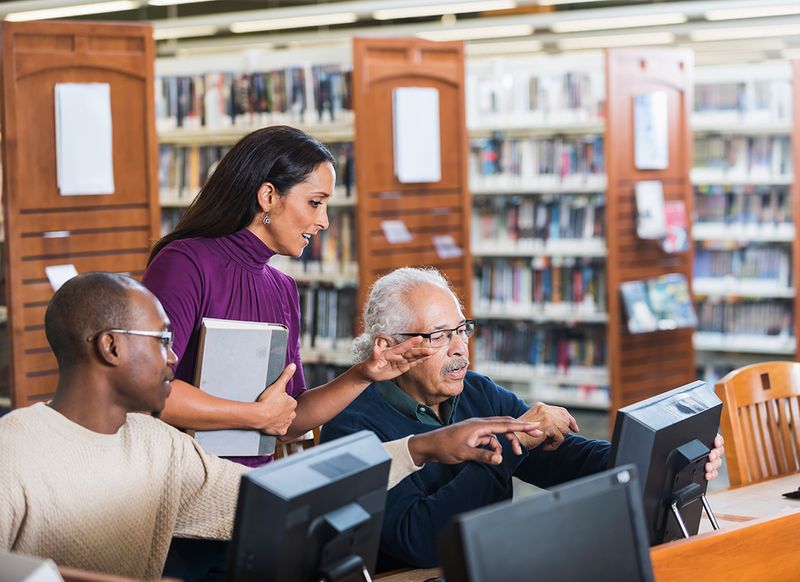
xmin=697 ymin=300 xmax=793 ymax=337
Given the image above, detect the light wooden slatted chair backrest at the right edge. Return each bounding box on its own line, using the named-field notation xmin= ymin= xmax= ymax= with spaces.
xmin=715 ymin=362 xmax=800 ymax=486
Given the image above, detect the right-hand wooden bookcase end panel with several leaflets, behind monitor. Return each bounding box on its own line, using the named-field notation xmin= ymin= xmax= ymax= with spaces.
xmin=605 ymin=48 xmax=695 ymax=423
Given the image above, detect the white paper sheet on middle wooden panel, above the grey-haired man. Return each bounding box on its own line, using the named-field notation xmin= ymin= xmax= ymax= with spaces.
xmin=392 ymin=87 xmax=442 ymax=183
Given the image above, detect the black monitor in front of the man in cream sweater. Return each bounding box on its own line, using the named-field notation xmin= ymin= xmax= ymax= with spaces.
xmin=227 ymin=431 xmax=390 ymax=582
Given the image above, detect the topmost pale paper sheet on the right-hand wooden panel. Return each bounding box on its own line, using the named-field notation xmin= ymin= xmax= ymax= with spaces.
xmin=633 ymin=91 xmax=669 ymax=170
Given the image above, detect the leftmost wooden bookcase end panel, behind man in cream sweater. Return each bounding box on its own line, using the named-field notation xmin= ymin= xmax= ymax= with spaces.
xmin=2 ymin=22 xmax=160 ymax=406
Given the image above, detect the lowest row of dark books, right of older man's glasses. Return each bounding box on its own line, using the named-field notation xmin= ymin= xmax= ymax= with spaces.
xmin=475 ymin=321 xmax=606 ymax=371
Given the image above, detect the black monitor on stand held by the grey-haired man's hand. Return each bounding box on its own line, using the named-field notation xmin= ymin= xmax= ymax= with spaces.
xmin=609 ymin=381 xmax=722 ymax=545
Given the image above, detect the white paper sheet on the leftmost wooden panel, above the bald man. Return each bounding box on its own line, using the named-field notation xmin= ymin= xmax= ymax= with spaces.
xmin=55 ymin=83 xmax=114 ymax=196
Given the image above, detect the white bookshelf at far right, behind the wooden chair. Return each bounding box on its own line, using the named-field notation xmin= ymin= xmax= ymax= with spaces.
xmin=691 ymin=63 xmax=798 ymax=382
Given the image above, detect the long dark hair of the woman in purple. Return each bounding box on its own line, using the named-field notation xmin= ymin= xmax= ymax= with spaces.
xmin=147 ymin=125 xmax=334 ymax=264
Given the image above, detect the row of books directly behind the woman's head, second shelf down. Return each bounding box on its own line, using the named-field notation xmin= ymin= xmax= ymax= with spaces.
xmin=158 ymin=142 xmax=355 ymax=203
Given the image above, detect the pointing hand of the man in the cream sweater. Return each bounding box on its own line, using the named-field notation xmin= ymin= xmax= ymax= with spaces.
xmin=408 ymin=416 xmax=542 ymax=466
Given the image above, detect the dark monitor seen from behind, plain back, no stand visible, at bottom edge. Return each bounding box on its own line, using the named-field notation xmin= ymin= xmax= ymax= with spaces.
xmin=438 ymin=465 xmax=653 ymax=582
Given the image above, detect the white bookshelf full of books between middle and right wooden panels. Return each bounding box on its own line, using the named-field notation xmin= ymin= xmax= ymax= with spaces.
xmin=467 ymin=53 xmax=611 ymax=410
